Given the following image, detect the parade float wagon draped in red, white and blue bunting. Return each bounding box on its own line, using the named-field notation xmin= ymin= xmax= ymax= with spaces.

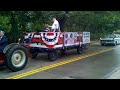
xmin=23 ymin=32 xmax=90 ymax=61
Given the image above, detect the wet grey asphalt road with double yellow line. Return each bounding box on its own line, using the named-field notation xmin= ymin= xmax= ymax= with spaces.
xmin=0 ymin=43 xmax=120 ymax=79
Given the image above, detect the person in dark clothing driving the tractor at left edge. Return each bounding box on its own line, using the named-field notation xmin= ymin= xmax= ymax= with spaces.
xmin=0 ymin=30 xmax=8 ymax=53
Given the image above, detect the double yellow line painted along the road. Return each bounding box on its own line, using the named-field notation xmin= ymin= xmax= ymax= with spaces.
xmin=6 ymin=48 xmax=114 ymax=79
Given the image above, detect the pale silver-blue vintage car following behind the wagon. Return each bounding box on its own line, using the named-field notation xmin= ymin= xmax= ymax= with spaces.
xmin=100 ymin=34 xmax=120 ymax=46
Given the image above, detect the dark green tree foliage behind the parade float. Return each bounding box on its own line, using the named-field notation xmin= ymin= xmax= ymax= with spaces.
xmin=0 ymin=11 xmax=120 ymax=42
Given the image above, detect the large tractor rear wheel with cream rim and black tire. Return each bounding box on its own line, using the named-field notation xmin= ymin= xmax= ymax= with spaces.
xmin=5 ymin=45 xmax=28 ymax=72
